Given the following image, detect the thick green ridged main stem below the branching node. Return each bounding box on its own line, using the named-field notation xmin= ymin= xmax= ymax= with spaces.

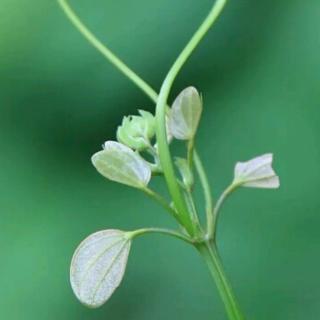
xmin=197 ymin=242 xmax=245 ymax=320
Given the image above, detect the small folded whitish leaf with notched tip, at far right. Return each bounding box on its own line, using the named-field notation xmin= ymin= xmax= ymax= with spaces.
xmin=234 ymin=153 xmax=280 ymax=189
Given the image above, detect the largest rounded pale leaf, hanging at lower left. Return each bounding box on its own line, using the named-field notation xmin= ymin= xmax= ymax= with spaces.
xmin=70 ymin=230 xmax=131 ymax=308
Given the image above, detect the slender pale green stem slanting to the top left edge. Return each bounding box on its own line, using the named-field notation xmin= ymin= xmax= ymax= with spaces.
xmin=58 ymin=0 xmax=158 ymax=103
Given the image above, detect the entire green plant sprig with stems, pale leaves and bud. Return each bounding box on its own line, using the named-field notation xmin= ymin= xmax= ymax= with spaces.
xmin=58 ymin=0 xmax=279 ymax=320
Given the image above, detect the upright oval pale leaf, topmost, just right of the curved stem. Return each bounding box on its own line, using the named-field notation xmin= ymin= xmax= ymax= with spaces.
xmin=169 ymin=87 xmax=202 ymax=140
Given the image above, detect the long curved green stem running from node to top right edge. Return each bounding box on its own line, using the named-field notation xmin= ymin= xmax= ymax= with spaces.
xmin=156 ymin=0 xmax=226 ymax=235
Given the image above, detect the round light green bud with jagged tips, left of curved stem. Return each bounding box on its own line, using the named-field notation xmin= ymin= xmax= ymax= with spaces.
xmin=117 ymin=110 xmax=156 ymax=151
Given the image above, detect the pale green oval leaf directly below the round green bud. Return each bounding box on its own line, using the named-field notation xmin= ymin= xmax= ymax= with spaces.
xmin=92 ymin=141 xmax=151 ymax=189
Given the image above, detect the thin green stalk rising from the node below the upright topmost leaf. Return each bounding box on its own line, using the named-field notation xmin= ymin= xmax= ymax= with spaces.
xmin=194 ymin=150 xmax=214 ymax=239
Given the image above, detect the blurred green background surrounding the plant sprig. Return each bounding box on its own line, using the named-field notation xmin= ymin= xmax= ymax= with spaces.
xmin=0 ymin=0 xmax=320 ymax=320
